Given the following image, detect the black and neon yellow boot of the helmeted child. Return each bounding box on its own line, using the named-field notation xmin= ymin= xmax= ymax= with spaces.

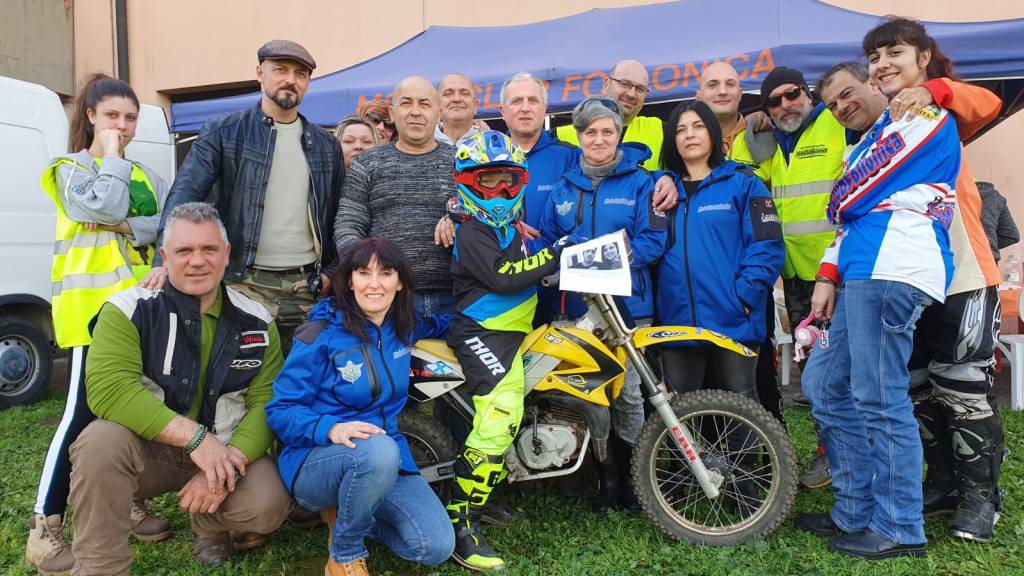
xmin=445 ymin=448 xmax=505 ymax=572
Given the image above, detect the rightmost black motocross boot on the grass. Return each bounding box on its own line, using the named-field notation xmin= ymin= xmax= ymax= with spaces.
xmin=949 ymin=414 xmax=1002 ymax=543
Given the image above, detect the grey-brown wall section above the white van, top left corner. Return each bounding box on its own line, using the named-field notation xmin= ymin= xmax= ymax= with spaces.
xmin=0 ymin=0 xmax=75 ymax=96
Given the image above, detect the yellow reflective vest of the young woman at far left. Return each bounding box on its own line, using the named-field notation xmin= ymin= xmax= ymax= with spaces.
xmin=40 ymin=158 xmax=156 ymax=348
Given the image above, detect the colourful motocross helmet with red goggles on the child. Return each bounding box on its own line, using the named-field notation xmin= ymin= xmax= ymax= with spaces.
xmin=453 ymin=130 xmax=529 ymax=229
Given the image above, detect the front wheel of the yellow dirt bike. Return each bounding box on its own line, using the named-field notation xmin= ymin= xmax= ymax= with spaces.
xmin=632 ymin=389 xmax=798 ymax=546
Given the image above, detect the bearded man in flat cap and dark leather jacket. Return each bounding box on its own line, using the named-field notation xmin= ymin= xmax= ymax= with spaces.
xmin=148 ymin=40 xmax=345 ymax=353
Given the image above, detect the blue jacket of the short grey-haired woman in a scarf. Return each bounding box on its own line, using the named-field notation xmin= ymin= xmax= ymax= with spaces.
xmin=530 ymin=142 xmax=666 ymax=319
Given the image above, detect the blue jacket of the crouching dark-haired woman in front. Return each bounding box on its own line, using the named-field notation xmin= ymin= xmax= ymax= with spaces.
xmin=264 ymin=298 xmax=452 ymax=492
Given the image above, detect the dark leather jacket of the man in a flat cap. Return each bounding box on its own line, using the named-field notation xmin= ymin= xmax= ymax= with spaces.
xmin=160 ymin=104 xmax=345 ymax=294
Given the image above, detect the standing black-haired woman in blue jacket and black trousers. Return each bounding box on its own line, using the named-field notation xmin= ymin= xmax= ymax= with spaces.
xmin=654 ymin=100 xmax=785 ymax=400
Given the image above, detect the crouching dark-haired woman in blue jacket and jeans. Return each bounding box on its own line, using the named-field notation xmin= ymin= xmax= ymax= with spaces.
xmin=265 ymin=238 xmax=455 ymax=576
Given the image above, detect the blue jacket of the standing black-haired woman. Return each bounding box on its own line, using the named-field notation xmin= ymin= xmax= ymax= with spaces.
xmin=655 ymin=161 xmax=785 ymax=345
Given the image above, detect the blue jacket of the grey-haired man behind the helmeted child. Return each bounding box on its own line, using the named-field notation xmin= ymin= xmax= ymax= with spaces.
xmin=522 ymin=130 xmax=580 ymax=230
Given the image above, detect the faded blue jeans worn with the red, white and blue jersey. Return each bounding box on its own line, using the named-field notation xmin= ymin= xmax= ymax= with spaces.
xmin=801 ymin=280 xmax=932 ymax=544
